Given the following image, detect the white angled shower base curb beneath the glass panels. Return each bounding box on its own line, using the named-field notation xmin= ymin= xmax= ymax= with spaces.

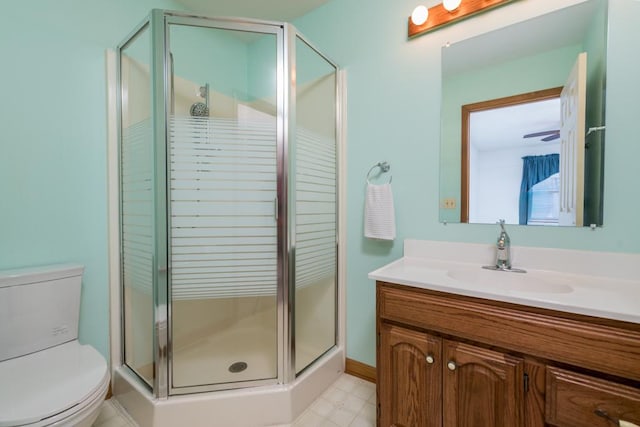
xmin=113 ymin=347 xmax=345 ymax=427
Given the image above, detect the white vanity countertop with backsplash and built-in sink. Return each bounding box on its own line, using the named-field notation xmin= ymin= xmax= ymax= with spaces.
xmin=369 ymin=241 xmax=640 ymax=323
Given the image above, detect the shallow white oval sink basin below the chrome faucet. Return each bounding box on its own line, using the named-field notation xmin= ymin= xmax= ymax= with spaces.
xmin=447 ymin=267 xmax=573 ymax=294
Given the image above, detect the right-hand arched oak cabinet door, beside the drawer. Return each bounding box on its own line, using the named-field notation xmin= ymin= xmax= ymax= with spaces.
xmin=442 ymin=340 xmax=524 ymax=427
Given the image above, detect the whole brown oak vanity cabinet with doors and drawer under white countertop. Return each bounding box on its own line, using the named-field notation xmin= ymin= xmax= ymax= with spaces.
xmin=377 ymin=282 xmax=640 ymax=427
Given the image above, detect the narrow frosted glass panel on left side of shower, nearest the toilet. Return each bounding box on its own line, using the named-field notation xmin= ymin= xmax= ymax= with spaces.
xmin=120 ymin=27 xmax=155 ymax=385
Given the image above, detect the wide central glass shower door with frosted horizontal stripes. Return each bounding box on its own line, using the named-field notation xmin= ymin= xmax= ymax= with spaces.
xmin=168 ymin=25 xmax=278 ymax=389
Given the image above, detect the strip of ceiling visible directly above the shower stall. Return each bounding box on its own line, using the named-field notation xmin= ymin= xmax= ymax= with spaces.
xmin=171 ymin=0 xmax=329 ymax=22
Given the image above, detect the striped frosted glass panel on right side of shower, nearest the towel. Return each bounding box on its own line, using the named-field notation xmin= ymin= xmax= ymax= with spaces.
xmin=292 ymin=38 xmax=338 ymax=372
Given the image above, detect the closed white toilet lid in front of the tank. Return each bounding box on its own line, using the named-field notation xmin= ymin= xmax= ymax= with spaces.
xmin=0 ymin=341 xmax=107 ymax=427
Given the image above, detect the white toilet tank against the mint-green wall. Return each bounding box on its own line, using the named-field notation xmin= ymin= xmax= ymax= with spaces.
xmin=0 ymin=265 xmax=84 ymax=362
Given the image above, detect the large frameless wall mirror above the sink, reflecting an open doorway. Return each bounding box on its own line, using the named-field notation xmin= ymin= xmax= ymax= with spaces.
xmin=440 ymin=0 xmax=607 ymax=225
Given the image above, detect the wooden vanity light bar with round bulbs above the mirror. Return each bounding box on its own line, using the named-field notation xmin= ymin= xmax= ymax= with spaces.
xmin=408 ymin=0 xmax=515 ymax=38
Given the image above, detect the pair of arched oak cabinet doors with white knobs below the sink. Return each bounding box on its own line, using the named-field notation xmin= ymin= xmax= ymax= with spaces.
xmin=378 ymin=324 xmax=524 ymax=427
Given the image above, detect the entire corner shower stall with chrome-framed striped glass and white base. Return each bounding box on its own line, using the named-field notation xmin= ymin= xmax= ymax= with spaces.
xmin=114 ymin=10 xmax=344 ymax=426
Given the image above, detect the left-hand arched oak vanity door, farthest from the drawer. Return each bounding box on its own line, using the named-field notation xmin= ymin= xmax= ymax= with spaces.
xmin=378 ymin=323 xmax=442 ymax=427
